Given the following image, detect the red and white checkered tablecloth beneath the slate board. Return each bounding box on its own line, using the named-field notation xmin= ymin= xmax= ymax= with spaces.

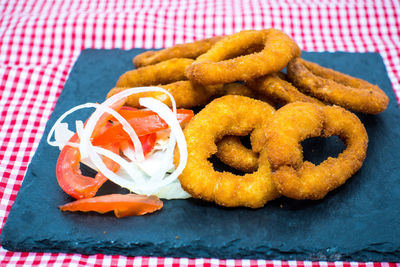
xmin=0 ymin=0 xmax=400 ymax=266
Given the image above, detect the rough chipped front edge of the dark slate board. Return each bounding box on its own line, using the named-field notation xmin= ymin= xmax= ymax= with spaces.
xmin=3 ymin=240 xmax=400 ymax=262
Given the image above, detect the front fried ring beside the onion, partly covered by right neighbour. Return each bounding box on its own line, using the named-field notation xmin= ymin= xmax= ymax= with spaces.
xmin=179 ymin=95 xmax=279 ymax=208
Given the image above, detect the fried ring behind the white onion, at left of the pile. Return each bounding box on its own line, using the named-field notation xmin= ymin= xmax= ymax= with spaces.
xmin=107 ymin=58 xmax=222 ymax=108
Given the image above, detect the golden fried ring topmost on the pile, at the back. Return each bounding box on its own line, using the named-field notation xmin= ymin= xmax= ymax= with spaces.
xmin=185 ymin=29 xmax=301 ymax=85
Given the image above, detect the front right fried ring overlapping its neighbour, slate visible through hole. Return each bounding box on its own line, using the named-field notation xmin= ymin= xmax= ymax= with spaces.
xmin=265 ymin=102 xmax=368 ymax=199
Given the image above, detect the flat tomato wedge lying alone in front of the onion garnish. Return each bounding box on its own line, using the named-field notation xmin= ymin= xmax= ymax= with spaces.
xmin=59 ymin=194 xmax=163 ymax=218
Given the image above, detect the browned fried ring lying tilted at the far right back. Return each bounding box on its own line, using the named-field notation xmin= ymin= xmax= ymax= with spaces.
xmin=287 ymin=58 xmax=389 ymax=114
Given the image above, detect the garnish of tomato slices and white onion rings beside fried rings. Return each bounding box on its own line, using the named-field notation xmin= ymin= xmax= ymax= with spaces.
xmin=47 ymin=87 xmax=193 ymax=217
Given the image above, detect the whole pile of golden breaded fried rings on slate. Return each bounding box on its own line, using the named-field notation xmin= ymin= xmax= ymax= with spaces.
xmin=108 ymin=29 xmax=388 ymax=208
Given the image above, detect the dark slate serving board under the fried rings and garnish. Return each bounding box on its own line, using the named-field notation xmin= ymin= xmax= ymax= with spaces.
xmin=1 ymin=49 xmax=400 ymax=261
